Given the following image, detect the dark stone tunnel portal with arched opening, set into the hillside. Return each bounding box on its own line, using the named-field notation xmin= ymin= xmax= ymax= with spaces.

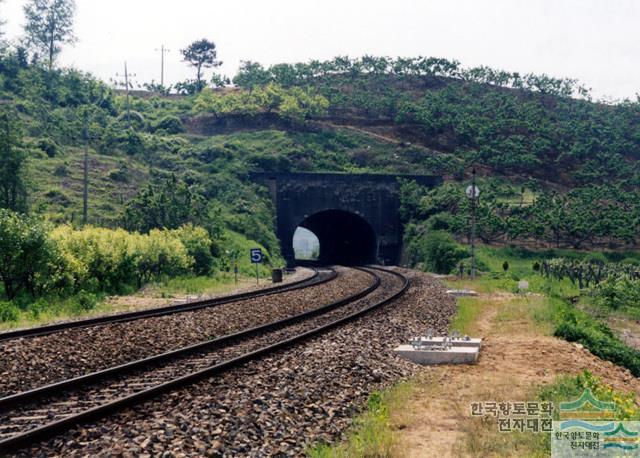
xmin=252 ymin=173 xmax=442 ymax=265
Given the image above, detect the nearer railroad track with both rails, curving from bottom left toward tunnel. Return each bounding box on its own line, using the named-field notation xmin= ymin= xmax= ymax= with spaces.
xmin=0 ymin=267 xmax=408 ymax=454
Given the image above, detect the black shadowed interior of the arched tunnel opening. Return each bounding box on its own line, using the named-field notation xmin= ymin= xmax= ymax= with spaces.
xmin=300 ymin=210 xmax=377 ymax=265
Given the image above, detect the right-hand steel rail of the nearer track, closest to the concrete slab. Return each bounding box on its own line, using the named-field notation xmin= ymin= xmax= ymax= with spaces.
xmin=0 ymin=267 xmax=409 ymax=454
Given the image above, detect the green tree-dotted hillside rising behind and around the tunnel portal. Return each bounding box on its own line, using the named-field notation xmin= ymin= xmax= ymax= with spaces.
xmin=0 ymin=55 xmax=640 ymax=253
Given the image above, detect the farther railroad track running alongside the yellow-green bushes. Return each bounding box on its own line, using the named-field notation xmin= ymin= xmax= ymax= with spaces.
xmin=0 ymin=268 xmax=338 ymax=342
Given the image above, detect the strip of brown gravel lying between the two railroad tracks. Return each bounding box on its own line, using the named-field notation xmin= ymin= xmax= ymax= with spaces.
xmin=0 ymin=268 xmax=372 ymax=396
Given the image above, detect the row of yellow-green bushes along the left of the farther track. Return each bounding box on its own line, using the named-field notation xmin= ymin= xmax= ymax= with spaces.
xmin=0 ymin=210 xmax=271 ymax=321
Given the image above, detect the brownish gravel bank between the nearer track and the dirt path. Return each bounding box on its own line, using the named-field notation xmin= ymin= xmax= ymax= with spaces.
xmin=16 ymin=271 xmax=455 ymax=458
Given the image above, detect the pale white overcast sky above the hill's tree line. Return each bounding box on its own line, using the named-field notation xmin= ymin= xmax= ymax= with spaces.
xmin=0 ymin=0 xmax=640 ymax=99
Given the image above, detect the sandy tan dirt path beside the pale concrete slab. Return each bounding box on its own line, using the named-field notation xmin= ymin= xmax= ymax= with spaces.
xmin=395 ymin=294 xmax=640 ymax=458
